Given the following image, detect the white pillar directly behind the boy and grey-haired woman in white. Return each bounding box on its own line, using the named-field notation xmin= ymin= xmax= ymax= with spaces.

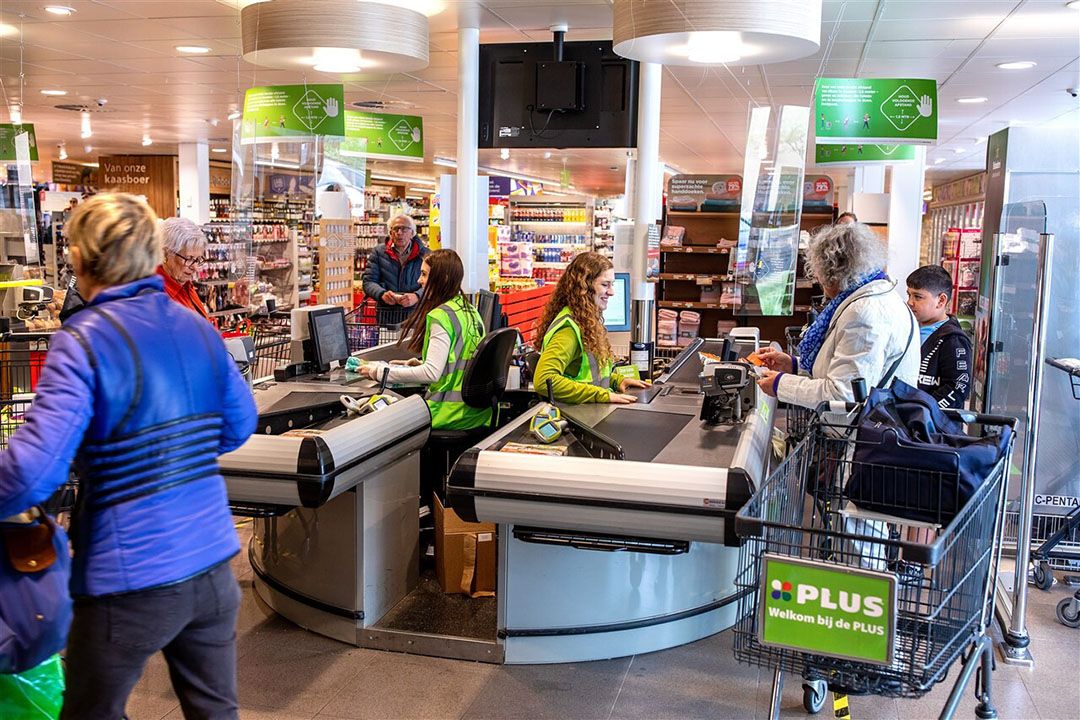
xmin=889 ymin=146 xmax=927 ymax=298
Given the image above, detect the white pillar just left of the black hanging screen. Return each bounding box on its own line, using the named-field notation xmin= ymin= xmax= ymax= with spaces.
xmin=454 ymin=27 xmax=488 ymax=293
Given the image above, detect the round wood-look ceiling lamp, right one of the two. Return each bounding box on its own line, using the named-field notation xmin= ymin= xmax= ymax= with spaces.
xmin=612 ymin=0 xmax=821 ymax=66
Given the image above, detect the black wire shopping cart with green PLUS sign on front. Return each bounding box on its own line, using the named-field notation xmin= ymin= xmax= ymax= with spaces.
xmin=734 ymin=395 xmax=1015 ymax=718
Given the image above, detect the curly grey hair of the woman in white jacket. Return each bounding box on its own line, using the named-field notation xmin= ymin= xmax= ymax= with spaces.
xmin=807 ymin=222 xmax=888 ymax=291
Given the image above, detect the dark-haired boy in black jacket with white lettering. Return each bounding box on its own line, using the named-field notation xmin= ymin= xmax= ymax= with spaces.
xmin=907 ymin=266 xmax=972 ymax=408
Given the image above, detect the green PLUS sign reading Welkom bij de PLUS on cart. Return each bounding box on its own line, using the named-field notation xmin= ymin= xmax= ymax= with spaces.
xmin=758 ymin=553 xmax=896 ymax=665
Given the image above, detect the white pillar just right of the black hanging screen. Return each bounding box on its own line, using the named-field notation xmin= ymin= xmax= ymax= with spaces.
xmin=630 ymin=63 xmax=664 ymax=342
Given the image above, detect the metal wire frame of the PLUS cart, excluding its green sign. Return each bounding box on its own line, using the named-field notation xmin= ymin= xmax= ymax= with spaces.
xmin=734 ymin=404 xmax=1015 ymax=718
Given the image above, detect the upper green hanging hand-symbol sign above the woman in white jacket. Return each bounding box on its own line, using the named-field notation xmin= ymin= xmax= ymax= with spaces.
xmin=813 ymin=78 xmax=937 ymax=145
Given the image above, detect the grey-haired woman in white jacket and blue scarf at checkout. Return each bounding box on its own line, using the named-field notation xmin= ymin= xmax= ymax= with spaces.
xmin=758 ymin=222 xmax=920 ymax=408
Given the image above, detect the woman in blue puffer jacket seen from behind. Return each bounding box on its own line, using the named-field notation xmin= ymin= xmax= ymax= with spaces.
xmin=0 ymin=194 xmax=256 ymax=720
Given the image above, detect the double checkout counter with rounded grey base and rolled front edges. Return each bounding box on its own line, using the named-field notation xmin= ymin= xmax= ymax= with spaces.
xmin=221 ymin=308 xmax=775 ymax=663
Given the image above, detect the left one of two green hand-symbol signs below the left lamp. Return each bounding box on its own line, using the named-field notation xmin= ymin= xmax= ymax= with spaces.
xmin=241 ymin=85 xmax=346 ymax=142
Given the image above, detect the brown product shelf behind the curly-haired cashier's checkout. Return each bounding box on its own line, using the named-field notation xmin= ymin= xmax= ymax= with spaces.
xmin=657 ymin=210 xmax=833 ymax=349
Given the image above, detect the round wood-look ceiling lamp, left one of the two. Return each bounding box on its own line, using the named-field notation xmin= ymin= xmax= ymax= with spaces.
xmin=240 ymin=0 xmax=429 ymax=74
